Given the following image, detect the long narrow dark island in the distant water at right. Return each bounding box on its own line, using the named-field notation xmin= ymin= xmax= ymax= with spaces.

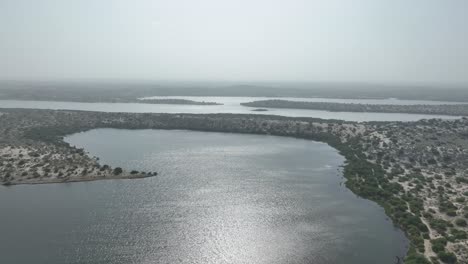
xmin=241 ymin=100 xmax=468 ymax=116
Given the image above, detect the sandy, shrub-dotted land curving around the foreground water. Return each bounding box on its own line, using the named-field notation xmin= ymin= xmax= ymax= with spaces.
xmin=0 ymin=109 xmax=468 ymax=264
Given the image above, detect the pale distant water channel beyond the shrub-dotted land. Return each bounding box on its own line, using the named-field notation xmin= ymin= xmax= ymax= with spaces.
xmin=0 ymin=96 xmax=460 ymax=122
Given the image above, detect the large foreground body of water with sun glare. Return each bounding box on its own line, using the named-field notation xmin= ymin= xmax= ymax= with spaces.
xmin=0 ymin=129 xmax=406 ymax=264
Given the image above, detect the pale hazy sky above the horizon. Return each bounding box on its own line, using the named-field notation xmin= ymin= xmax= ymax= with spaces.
xmin=0 ymin=0 xmax=468 ymax=83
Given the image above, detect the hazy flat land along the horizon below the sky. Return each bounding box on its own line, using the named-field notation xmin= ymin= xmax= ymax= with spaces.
xmin=0 ymin=81 xmax=468 ymax=102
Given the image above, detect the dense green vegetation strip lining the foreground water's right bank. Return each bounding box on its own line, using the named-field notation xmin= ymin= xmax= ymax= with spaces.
xmin=328 ymin=140 xmax=430 ymax=264
